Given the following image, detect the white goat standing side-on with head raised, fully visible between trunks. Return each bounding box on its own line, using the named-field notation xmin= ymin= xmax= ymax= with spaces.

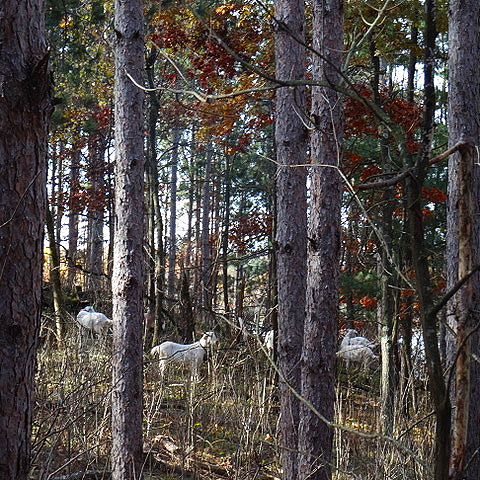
xmin=150 ymin=332 xmax=217 ymax=378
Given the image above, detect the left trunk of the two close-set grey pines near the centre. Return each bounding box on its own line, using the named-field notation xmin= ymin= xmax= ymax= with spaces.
xmin=275 ymin=0 xmax=307 ymax=480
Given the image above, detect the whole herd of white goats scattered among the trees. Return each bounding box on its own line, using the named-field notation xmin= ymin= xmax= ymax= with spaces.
xmin=76 ymin=306 xmax=404 ymax=377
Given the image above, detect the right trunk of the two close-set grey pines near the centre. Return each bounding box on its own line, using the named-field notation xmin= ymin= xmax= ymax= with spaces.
xmin=297 ymin=0 xmax=343 ymax=480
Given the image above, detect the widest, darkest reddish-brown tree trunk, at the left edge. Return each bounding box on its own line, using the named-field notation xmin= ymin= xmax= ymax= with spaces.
xmin=0 ymin=0 xmax=52 ymax=480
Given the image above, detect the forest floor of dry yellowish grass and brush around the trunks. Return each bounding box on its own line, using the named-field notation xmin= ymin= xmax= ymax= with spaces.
xmin=31 ymin=324 xmax=433 ymax=480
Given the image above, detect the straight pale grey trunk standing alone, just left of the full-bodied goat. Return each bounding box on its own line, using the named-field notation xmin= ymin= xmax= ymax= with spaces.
xmin=112 ymin=0 xmax=145 ymax=480
